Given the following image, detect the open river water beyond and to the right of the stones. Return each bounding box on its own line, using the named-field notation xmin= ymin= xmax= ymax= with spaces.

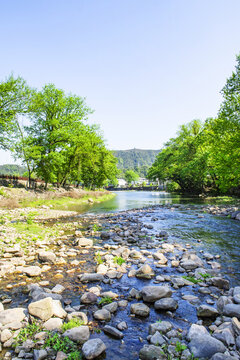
xmin=72 ymin=191 xmax=240 ymax=284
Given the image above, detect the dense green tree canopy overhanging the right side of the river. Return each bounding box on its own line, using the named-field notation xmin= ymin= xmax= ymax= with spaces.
xmin=148 ymin=55 xmax=240 ymax=194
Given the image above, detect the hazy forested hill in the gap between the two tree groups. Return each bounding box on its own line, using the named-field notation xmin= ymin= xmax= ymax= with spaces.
xmin=113 ymin=149 xmax=160 ymax=177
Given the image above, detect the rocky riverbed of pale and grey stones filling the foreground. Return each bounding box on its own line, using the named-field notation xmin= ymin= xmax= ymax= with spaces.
xmin=0 ymin=207 xmax=240 ymax=360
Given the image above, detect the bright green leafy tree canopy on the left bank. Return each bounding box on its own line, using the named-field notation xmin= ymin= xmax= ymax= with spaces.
xmin=0 ymin=76 xmax=117 ymax=188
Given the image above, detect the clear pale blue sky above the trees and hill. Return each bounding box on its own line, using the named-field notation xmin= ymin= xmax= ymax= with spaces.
xmin=0 ymin=0 xmax=240 ymax=163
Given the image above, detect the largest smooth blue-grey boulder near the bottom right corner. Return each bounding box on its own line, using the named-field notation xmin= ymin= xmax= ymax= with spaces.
xmin=189 ymin=335 xmax=226 ymax=359
